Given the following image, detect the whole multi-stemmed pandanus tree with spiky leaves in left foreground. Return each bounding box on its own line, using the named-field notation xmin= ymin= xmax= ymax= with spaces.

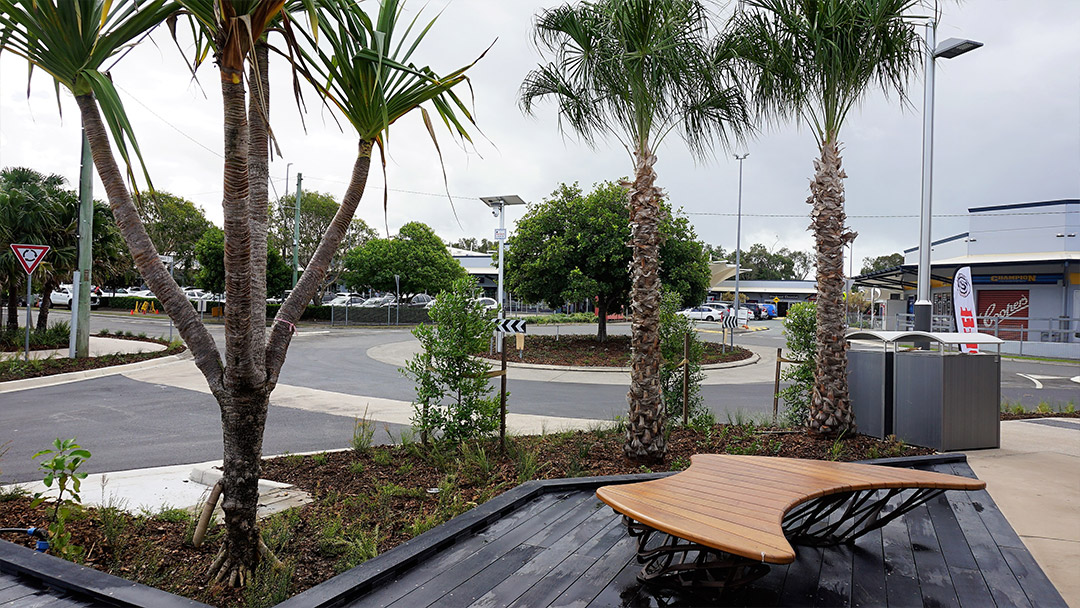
xmin=0 ymin=0 xmax=481 ymax=585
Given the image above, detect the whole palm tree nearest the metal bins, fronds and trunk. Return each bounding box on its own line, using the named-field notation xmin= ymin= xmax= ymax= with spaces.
xmin=734 ymin=0 xmax=922 ymax=435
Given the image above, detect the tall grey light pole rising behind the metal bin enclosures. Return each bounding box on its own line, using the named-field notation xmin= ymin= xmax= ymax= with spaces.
xmin=915 ymin=19 xmax=983 ymax=332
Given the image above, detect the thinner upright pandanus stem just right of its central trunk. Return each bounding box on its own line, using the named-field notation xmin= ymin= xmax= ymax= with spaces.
xmin=247 ymin=41 xmax=270 ymax=377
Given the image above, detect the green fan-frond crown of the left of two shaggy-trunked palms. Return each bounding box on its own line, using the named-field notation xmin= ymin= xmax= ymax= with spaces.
xmin=519 ymin=0 xmax=748 ymax=156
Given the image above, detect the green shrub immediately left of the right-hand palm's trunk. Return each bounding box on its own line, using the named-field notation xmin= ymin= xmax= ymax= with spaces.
xmin=780 ymin=302 xmax=818 ymax=427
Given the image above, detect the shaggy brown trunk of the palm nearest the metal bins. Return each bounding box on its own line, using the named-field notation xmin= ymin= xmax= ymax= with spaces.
xmin=807 ymin=140 xmax=855 ymax=436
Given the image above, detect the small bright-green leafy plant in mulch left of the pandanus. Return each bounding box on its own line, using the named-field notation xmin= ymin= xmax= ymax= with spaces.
xmin=30 ymin=437 xmax=90 ymax=559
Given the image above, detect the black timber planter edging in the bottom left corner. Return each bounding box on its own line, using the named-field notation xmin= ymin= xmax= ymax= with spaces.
xmin=0 ymin=540 xmax=210 ymax=608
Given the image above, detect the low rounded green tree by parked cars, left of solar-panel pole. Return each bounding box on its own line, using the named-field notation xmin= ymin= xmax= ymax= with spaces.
xmin=342 ymin=221 xmax=468 ymax=294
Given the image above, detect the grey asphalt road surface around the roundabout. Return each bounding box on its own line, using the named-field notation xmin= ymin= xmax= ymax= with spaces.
xmin=0 ymin=311 xmax=1080 ymax=483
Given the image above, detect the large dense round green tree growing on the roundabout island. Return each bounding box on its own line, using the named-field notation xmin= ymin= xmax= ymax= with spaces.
xmin=504 ymin=181 xmax=710 ymax=340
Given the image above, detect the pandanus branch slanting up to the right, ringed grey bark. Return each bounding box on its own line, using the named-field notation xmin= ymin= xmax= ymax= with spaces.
xmin=267 ymin=139 xmax=374 ymax=390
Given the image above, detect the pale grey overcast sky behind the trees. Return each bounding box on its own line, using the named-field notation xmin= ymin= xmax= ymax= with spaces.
xmin=0 ymin=0 xmax=1080 ymax=273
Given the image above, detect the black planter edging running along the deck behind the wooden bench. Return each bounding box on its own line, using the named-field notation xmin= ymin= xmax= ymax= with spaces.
xmin=274 ymin=454 xmax=968 ymax=608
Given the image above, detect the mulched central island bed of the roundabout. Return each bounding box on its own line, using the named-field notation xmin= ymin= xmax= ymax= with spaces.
xmin=477 ymin=335 xmax=754 ymax=367
